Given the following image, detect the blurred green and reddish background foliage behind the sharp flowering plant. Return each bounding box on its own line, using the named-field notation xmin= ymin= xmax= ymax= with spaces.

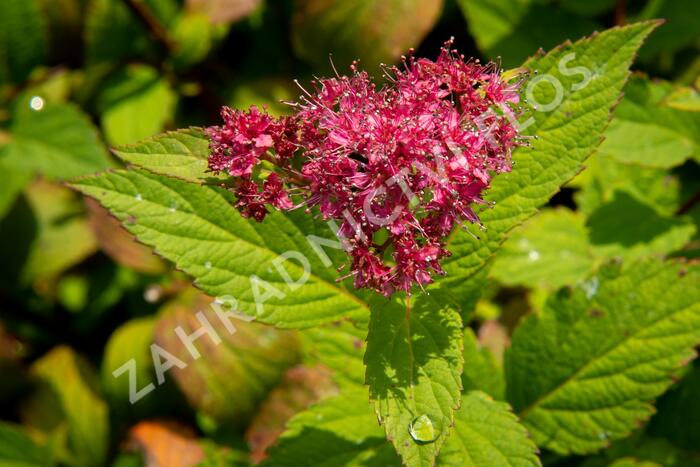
xmin=0 ymin=0 xmax=700 ymax=466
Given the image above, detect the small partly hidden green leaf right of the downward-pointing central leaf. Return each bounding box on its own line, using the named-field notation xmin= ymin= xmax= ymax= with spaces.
xmin=462 ymin=328 xmax=506 ymax=400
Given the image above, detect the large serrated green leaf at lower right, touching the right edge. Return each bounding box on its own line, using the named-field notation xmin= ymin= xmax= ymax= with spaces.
xmin=505 ymin=260 xmax=700 ymax=453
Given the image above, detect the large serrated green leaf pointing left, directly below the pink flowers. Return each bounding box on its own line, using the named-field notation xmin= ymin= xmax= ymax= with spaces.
xmin=73 ymin=170 xmax=367 ymax=328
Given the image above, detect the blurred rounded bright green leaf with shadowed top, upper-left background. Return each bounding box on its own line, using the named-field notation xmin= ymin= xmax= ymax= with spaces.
xmin=98 ymin=65 xmax=177 ymax=144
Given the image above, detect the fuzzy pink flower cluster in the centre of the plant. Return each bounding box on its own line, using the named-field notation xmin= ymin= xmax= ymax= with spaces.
xmin=208 ymin=42 xmax=523 ymax=295
